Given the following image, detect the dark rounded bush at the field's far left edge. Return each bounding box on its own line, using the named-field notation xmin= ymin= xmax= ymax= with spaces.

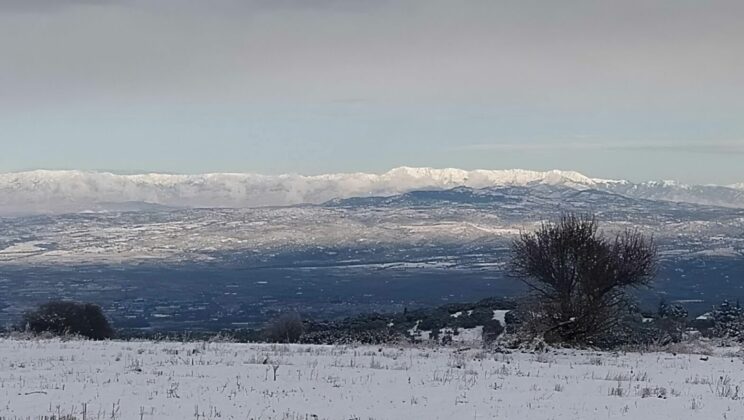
xmin=22 ymin=301 xmax=114 ymax=340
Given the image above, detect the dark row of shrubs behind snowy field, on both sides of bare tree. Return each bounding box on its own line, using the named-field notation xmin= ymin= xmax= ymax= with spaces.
xmin=7 ymin=298 xmax=744 ymax=348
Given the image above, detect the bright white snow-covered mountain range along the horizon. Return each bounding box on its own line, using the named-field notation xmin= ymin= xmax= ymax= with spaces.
xmin=0 ymin=167 xmax=744 ymax=215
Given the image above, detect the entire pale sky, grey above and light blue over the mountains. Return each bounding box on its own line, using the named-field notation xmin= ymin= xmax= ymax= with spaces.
xmin=0 ymin=0 xmax=744 ymax=184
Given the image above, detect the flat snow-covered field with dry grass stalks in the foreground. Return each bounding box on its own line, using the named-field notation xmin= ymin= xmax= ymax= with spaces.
xmin=0 ymin=339 xmax=744 ymax=420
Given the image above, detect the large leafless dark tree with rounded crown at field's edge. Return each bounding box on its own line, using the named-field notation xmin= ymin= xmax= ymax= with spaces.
xmin=510 ymin=214 xmax=657 ymax=343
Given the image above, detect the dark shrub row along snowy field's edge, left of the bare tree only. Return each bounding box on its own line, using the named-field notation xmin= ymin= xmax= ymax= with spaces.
xmin=4 ymin=298 xmax=517 ymax=344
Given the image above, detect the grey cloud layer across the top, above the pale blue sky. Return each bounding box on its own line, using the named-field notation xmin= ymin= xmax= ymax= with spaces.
xmin=0 ymin=0 xmax=744 ymax=108
